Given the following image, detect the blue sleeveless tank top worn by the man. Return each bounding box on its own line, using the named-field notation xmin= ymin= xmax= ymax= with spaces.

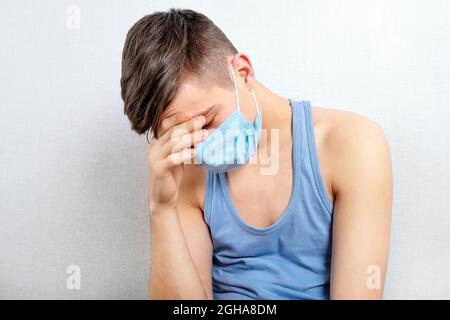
xmin=204 ymin=99 xmax=333 ymax=300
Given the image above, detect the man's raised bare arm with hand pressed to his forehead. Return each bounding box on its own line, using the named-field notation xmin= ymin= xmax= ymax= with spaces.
xmin=148 ymin=113 xmax=212 ymax=299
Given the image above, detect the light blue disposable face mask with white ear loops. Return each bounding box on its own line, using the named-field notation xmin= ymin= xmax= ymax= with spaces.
xmin=194 ymin=65 xmax=262 ymax=172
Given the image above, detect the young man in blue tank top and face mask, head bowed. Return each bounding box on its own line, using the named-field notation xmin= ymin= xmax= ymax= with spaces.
xmin=121 ymin=9 xmax=392 ymax=299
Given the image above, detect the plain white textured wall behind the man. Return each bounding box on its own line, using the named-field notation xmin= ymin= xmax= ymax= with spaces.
xmin=0 ymin=0 xmax=450 ymax=299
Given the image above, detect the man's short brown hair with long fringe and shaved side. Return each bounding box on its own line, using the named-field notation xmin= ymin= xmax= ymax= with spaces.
xmin=120 ymin=8 xmax=237 ymax=136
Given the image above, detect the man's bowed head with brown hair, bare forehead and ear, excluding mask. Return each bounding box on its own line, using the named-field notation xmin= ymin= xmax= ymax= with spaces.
xmin=121 ymin=9 xmax=253 ymax=137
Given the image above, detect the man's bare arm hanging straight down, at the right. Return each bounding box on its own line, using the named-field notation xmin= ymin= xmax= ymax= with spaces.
xmin=330 ymin=113 xmax=392 ymax=299
